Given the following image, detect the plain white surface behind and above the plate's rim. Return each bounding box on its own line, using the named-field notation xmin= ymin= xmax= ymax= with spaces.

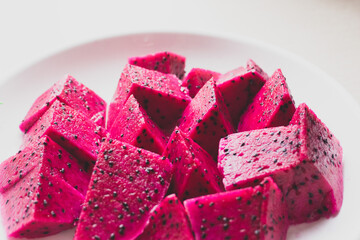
xmin=0 ymin=0 xmax=360 ymax=103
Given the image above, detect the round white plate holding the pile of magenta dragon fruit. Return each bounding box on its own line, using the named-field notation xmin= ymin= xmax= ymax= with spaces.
xmin=0 ymin=33 xmax=360 ymax=240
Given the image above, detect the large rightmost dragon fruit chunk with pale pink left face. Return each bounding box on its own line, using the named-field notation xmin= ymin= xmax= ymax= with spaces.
xmin=218 ymin=107 xmax=343 ymax=224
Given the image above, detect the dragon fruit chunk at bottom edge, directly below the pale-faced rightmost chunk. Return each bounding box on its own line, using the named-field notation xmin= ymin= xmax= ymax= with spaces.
xmin=184 ymin=178 xmax=288 ymax=239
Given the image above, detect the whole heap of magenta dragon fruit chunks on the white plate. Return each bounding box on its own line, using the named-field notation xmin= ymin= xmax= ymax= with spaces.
xmin=0 ymin=52 xmax=343 ymax=240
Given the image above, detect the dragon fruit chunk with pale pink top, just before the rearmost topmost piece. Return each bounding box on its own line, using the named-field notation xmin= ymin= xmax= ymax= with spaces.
xmin=107 ymin=64 xmax=191 ymax=133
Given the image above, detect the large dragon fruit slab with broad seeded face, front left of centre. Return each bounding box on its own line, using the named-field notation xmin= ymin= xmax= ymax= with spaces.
xmin=74 ymin=139 xmax=172 ymax=240
